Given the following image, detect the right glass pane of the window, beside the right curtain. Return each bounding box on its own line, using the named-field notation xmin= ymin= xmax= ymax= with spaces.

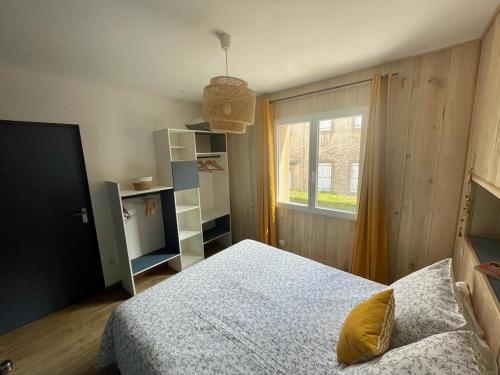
xmin=316 ymin=115 xmax=363 ymax=212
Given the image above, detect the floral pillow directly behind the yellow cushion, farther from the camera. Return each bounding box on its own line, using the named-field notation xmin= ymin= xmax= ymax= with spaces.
xmin=390 ymin=259 xmax=466 ymax=347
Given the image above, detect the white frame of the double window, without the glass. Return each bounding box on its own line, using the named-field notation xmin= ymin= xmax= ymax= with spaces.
xmin=274 ymin=106 xmax=368 ymax=221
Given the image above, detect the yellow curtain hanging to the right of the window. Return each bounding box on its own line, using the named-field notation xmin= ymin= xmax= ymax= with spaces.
xmin=352 ymin=74 xmax=389 ymax=284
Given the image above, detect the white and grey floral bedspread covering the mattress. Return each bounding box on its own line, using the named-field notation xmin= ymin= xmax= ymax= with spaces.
xmin=97 ymin=240 xmax=384 ymax=375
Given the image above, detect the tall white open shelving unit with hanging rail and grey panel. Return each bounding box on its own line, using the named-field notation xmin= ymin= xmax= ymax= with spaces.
xmin=154 ymin=129 xmax=231 ymax=270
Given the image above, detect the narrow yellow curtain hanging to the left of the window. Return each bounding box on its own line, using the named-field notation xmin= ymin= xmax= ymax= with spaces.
xmin=257 ymin=98 xmax=276 ymax=246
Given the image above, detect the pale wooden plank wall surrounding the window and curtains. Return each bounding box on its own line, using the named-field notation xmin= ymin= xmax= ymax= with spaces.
xmin=229 ymin=41 xmax=480 ymax=279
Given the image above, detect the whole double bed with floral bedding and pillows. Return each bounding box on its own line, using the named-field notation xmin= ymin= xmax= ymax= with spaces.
xmin=97 ymin=240 xmax=500 ymax=375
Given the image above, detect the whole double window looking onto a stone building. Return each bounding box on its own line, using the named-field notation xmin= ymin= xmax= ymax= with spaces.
xmin=276 ymin=108 xmax=365 ymax=217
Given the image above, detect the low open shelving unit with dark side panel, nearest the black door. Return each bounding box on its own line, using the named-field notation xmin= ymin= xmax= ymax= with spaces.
xmin=106 ymin=181 xmax=180 ymax=296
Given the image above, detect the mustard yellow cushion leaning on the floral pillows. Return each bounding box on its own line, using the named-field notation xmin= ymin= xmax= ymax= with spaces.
xmin=337 ymin=289 xmax=394 ymax=365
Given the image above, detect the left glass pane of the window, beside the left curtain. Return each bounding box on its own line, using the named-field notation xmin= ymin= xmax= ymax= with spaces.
xmin=278 ymin=122 xmax=310 ymax=206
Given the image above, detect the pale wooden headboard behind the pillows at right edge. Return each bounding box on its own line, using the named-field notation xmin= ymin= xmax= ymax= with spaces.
xmin=453 ymin=237 xmax=500 ymax=367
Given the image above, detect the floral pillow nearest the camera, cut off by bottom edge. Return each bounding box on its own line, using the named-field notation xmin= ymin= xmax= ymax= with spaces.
xmin=340 ymin=331 xmax=496 ymax=375
